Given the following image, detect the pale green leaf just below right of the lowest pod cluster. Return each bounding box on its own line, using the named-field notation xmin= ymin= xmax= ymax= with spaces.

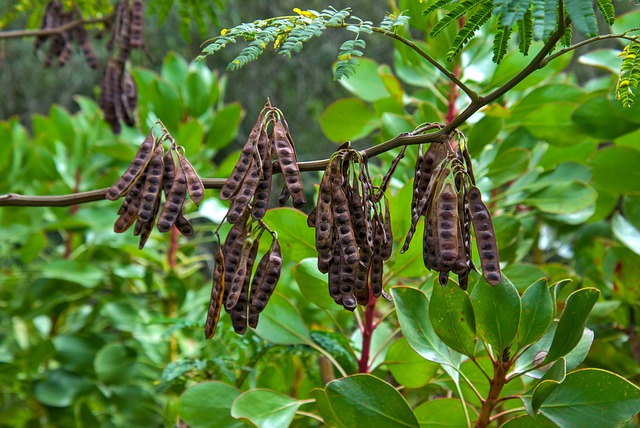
xmin=256 ymin=292 xmax=311 ymax=345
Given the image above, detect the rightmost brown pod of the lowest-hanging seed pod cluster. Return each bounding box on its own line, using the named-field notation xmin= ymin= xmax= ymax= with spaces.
xmin=249 ymin=238 xmax=282 ymax=328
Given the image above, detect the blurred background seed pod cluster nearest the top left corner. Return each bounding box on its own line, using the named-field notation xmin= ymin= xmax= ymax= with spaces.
xmin=33 ymin=0 xmax=98 ymax=70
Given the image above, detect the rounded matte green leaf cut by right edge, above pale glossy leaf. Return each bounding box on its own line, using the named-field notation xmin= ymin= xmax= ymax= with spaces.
xmin=590 ymin=146 xmax=640 ymax=195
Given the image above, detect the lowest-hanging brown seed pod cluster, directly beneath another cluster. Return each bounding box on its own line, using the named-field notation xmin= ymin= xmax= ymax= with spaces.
xmin=204 ymin=216 xmax=282 ymax=339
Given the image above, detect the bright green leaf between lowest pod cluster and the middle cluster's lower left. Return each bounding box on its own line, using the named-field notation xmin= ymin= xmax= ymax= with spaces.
xmin=292 ymin=257 xmax=343 ymax=311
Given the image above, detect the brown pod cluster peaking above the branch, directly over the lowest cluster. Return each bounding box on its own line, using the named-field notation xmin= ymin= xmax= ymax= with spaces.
xmin=220 ymin=102 xmax=306 ymax=224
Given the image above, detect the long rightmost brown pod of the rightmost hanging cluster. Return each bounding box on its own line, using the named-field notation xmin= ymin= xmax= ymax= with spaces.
xmin=467 ymin=186 xmax=502 ymax=286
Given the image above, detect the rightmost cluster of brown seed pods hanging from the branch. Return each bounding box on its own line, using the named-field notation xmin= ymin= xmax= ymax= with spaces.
xmin=400 ymin=135 xmax=502 ymax=289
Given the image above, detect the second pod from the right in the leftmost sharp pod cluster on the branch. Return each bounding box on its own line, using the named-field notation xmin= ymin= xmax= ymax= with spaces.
xmin=157 ymin=151 xmax=187 ymax=232
